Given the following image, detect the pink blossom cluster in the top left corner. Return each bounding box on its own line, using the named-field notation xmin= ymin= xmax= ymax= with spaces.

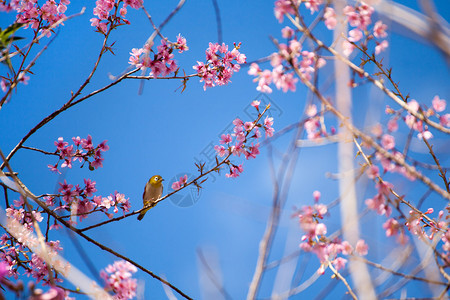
xmin=0 ymin=0 xmax=70 ymax=35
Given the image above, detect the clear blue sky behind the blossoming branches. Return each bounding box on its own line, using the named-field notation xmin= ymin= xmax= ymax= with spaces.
xmin=0 ymin=1 xmax=450 ymax=299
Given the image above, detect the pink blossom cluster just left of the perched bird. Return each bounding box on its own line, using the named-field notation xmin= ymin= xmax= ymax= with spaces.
xmin=53 ymin=179 xmax=131 ymax=222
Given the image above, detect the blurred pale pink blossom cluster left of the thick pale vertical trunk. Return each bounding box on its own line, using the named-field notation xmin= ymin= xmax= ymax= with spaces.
xmin=248 ymin=35 xmax=326 ymax=93
